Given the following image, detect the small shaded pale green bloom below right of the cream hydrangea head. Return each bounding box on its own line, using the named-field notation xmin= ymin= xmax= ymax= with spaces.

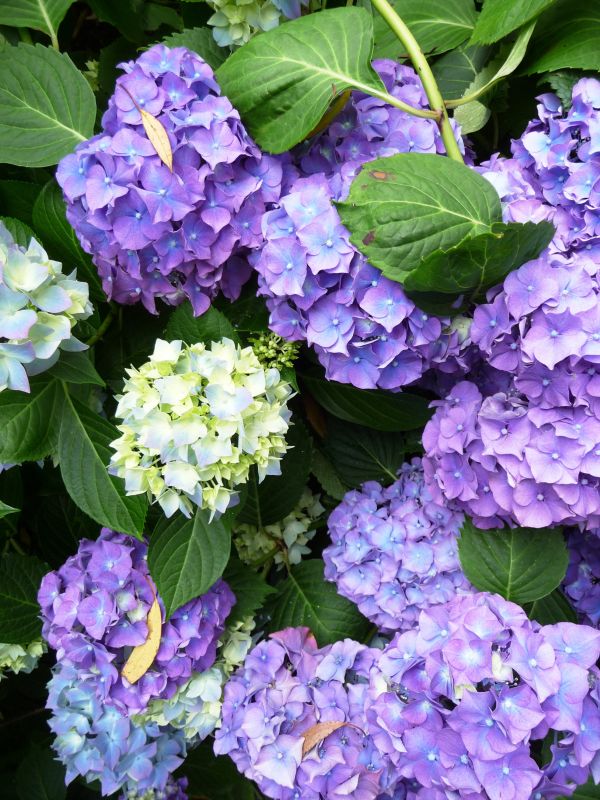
xmin=234 ymin=488 xmax=325 ymax=565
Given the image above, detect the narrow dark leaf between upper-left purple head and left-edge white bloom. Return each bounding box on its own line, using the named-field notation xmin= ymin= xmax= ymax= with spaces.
xmin=33 ymin=179 xmax=106 ymax=300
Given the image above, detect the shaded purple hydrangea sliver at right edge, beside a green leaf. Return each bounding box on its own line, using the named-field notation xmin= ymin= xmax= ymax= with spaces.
xmin=563 ymin=530 xmax=600 ymax=629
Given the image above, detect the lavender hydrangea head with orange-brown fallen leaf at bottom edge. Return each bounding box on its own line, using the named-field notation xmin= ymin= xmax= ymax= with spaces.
xmin=214 ymin=628 xmax=389 ymax=800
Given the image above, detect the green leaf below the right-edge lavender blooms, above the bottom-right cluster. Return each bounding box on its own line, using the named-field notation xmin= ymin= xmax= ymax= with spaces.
xmin=458 ymin=520 xmax=569 ymax=605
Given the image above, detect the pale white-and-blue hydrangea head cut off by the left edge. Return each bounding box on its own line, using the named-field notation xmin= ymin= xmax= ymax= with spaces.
xmin=0 ymin=222 xmax=93 ymax=392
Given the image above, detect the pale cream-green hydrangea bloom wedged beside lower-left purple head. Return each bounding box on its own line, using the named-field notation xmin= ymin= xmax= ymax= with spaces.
xmin=135 ymin=618 xmax=254 ymax=745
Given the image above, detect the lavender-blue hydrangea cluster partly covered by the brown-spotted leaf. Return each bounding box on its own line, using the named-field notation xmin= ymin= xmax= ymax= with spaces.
xmin=251 ymin=61 xmax=461 ymax=390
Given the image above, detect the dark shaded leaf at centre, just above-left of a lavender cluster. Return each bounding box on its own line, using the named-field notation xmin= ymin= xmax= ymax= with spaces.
xmin=325 ymin=420 xmax=405 ymax=489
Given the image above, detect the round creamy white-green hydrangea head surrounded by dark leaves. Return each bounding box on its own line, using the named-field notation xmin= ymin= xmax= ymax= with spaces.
xmin=109 ymin=339 xmax=292 ymax=517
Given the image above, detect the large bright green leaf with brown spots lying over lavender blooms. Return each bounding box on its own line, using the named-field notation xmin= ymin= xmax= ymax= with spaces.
xmin=336 ymin=153 xmax=502 ymax=281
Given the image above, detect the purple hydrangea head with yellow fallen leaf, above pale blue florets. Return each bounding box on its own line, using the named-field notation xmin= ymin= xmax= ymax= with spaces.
xmin=38 ymin=528 xmax=235 ymax=715
